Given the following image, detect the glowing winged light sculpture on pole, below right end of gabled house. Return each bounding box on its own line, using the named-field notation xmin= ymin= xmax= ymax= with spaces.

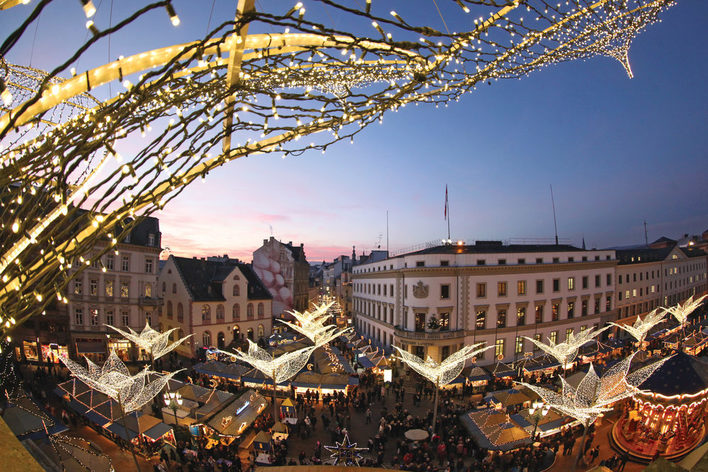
xmin=227 ymin=339 xmax=317 ymax=421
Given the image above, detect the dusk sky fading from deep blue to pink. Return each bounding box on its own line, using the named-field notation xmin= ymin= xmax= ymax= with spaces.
xmin=0 ymin=0 xmax=708 ymax=262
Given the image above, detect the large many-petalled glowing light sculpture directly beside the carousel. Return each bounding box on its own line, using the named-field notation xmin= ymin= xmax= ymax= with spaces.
xmin=519 ymin=351 xmax=669 ymax=464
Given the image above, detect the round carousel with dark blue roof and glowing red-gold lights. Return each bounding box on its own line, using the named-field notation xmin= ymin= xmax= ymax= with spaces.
xmin=612 ymin=352 xmax=708 ymax=461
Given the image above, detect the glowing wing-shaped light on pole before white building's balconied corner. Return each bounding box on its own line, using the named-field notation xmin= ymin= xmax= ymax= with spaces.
xmin=393 ymin=343 xmax=493 ymax=433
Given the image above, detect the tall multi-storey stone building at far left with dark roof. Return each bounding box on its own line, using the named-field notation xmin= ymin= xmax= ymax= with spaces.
xmin=67 ymin=217 xmax=162 ymax=360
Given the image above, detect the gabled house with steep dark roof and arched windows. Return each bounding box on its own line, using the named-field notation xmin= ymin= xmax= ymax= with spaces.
xmin=159 ymin=256 xmax=273 ymax=357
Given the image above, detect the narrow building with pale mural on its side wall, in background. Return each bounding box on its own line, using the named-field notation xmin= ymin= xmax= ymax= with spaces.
xmin=253 ymin=236 xmax=310 ymax=317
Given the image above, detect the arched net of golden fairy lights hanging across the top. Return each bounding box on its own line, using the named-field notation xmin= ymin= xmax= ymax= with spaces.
xmin=0 ymin=0 xmax=674 ymax=337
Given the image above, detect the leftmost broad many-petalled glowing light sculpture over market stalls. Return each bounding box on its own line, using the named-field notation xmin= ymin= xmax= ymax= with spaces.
xmin=59 ymin=350 xmax=177 ymax=413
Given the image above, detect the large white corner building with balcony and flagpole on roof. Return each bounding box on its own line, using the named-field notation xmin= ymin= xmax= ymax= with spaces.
xmin=352 ymin=241 xmax=617 ymax=364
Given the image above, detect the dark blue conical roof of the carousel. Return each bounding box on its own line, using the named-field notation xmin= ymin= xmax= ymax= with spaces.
xmin=639 ymin=352 xmax=708 ymax=396
